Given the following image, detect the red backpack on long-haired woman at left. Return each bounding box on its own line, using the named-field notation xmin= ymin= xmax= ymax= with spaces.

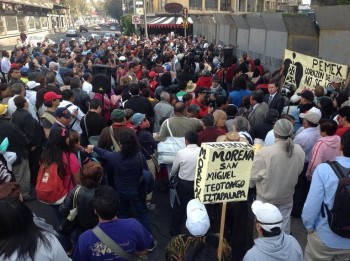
xmin=35 ymin=163 xmax=67 ymax=204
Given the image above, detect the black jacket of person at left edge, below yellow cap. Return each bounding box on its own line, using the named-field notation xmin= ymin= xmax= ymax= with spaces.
xmin=0 ymin=118 xmax=29 ymax=166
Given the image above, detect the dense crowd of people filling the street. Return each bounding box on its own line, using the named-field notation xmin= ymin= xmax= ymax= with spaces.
xmin=0 ymin=31 xmax=350 ymax=260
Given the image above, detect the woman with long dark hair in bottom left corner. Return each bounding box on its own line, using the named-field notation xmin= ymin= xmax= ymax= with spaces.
xmin=0 ymin=183 xmax=70 ymax=261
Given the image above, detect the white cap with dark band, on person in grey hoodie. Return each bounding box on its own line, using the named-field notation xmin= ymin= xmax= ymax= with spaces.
xmin=252 ymin=200 xmax=283 ymax=232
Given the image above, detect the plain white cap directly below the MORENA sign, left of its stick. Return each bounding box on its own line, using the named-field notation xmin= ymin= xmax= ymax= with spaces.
xmin=186 ymin=199 xmax=210 ymax=236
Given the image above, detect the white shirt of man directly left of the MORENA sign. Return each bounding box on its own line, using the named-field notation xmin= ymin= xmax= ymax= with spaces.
xmin=171 ymin=144 xmax=201 ymax=181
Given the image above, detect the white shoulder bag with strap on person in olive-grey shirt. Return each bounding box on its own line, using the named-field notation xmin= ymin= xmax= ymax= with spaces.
xmin=158 ymin=119 xmax=186 ymax=164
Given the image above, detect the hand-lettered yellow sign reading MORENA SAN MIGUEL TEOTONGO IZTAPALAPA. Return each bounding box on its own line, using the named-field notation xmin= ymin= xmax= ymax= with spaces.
xmin=194 ymin=142 xmax=254 ymax=203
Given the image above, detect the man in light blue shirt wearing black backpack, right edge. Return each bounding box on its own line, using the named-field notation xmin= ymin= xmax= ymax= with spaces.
xmin=302 ymin=131 xmax=350 ymax=261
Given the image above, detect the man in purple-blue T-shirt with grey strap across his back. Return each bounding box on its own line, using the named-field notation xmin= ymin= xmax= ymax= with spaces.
xmin=74 ymin=186 xmax=153 ymax=261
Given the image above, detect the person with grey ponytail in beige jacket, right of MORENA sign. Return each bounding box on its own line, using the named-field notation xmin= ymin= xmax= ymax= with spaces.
xmin=250 ymin=119 xmax=305 ymax=234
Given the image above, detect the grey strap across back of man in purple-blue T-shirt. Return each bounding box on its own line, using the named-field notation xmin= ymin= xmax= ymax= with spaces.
xmin=92 ymin=226 xmax=148 ymax=261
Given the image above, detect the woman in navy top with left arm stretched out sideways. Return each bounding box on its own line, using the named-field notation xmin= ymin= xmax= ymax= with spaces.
xmin=88 ymin=132 xmax=151 ymax=239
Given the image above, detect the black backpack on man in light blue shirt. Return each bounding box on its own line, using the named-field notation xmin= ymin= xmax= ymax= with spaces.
xmin=321 ymin=161 xmax=350 ymax=238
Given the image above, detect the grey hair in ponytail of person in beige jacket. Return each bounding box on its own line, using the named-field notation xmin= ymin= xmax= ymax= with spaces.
xmin=273 ymin=119 xmax=294 ymax=157
